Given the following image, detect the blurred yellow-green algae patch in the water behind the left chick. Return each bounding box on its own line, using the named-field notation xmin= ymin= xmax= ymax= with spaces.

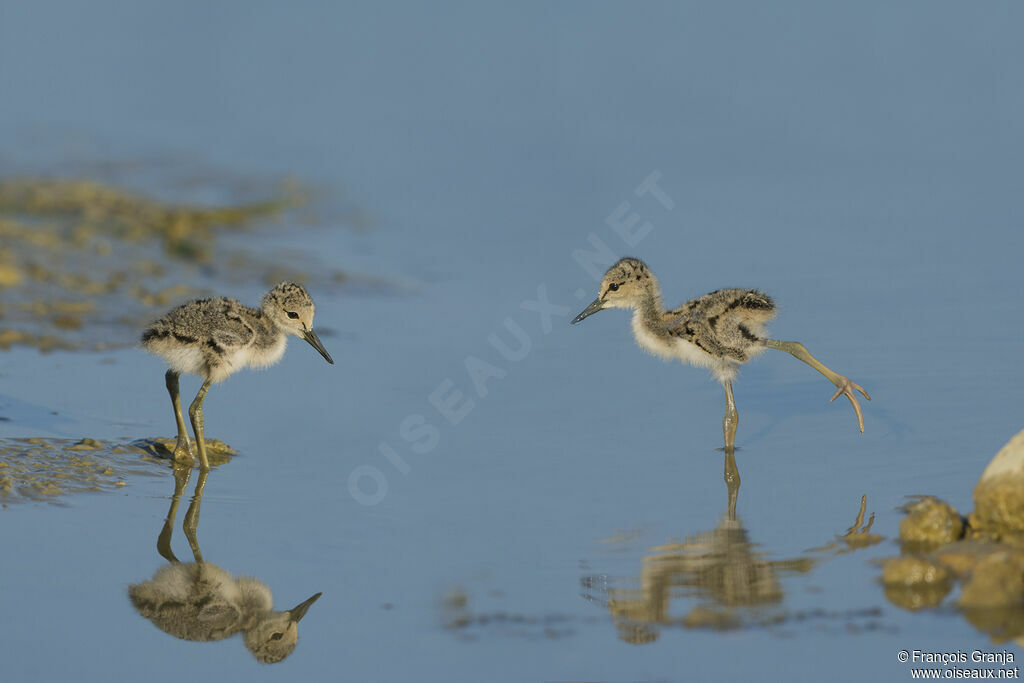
xmin=0 ymin=178 xmax=305 ymax=351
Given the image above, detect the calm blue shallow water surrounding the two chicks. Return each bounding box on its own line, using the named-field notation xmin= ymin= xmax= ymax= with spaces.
xmin=0 ymin=3 xmax=1024 ymax=681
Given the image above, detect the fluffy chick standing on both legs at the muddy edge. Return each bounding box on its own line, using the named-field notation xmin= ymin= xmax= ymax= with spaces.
xmin=142 ymin=283 xmax=334 ymax=470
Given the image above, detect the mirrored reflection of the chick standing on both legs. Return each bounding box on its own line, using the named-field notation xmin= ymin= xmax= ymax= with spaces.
xmin=128 ymin=466 xmax=321 ymax=664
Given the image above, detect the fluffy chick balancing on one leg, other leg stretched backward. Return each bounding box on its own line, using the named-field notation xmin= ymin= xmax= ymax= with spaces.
xmin=571 ymin=258 xmax=871 ymax=451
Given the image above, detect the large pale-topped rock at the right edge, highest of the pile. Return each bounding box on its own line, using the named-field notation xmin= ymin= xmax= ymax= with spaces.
xmin=971 ymin=431 xmax=1024 ymax=541
